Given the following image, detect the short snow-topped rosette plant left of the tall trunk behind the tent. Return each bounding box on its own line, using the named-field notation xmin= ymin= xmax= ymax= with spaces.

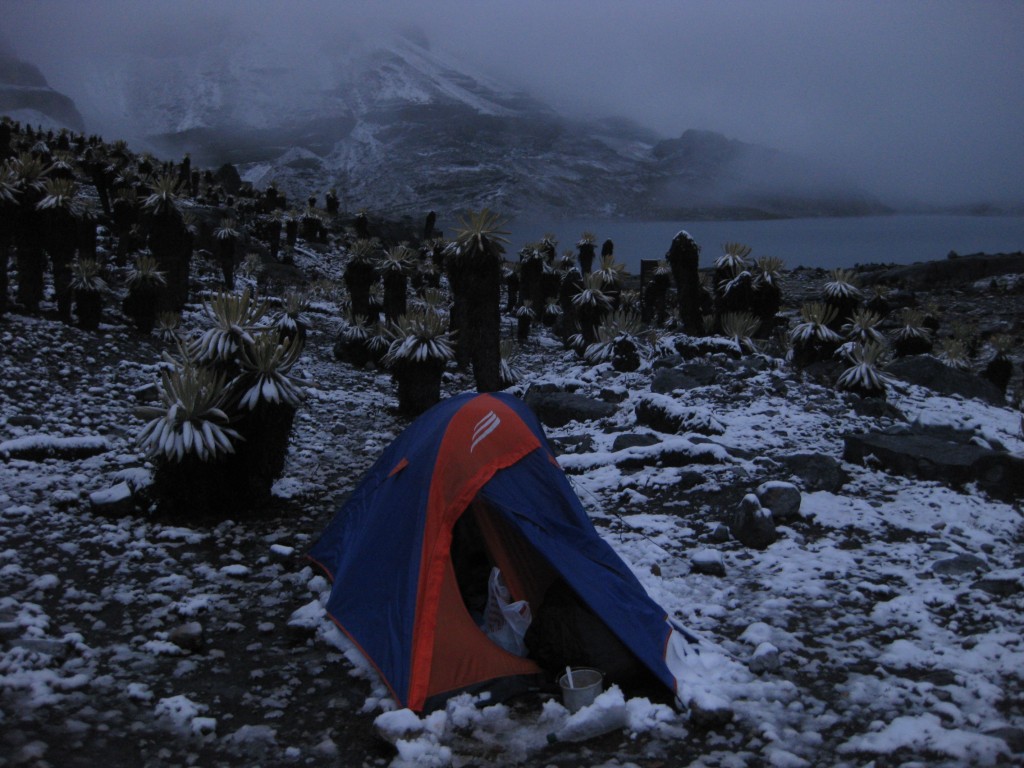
xmin=382 ymin=311 xmax=455 ymax=417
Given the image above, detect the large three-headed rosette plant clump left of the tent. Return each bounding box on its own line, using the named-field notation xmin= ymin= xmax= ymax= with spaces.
xmin=140 ymin=290 xmax=304 ymax=514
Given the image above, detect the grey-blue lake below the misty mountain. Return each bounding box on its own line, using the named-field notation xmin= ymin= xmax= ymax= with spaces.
xmin=506 ymin=215 xmax=1024 ymax=274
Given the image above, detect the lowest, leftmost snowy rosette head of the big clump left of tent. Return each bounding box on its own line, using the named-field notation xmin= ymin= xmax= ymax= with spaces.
xmin=136 ymin=350 xmax=241 ymax=462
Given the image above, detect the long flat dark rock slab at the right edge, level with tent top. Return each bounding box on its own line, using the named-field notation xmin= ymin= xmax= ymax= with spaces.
xmin=843 ymin=430 xmax=1024 ymax=500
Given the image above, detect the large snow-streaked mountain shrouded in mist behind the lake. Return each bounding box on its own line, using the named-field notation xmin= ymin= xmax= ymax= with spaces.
xmin=12 ymin=30 xmax=882 ymax=218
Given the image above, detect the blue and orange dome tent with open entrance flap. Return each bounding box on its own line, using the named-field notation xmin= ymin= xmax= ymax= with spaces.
xmin=309 ymin=393 xmax=691 ymax=712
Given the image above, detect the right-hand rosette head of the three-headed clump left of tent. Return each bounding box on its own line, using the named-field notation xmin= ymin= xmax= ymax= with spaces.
xmin=228 ymin=333 xmax=305 ymax=411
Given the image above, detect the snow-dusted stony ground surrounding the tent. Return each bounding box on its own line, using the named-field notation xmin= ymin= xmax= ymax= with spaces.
xmin=0 ymin=256 xmax=1024 ymax=767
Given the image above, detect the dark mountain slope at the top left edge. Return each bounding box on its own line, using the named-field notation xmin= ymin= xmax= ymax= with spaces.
xmin=0 ymin=51 xmax=85 ymax=131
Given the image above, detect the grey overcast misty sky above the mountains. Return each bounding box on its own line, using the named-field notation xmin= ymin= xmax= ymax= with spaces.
xmin=0 ymin=0 xmax=1024 ymax=202
